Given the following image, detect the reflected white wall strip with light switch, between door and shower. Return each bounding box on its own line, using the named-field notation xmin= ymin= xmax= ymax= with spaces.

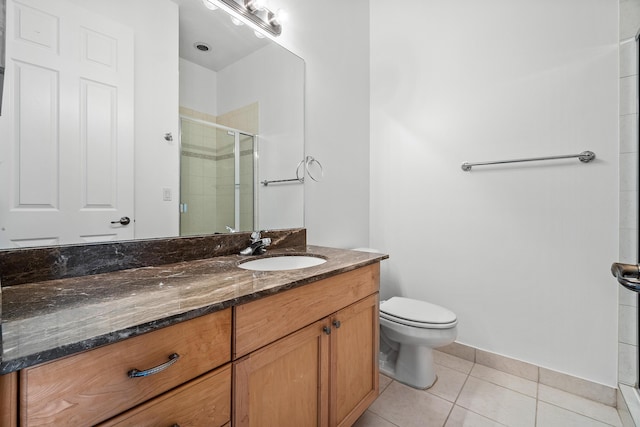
xmin=74 ymin=0 xmax=180 ymax=238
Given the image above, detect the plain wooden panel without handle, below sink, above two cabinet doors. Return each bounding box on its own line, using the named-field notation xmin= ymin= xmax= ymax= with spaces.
xmin=234 ymin=263 xmax=380 ymax=359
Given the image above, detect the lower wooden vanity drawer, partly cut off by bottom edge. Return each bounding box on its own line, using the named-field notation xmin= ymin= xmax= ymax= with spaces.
xmin=100 ymin=364 xmax=231 ymax=427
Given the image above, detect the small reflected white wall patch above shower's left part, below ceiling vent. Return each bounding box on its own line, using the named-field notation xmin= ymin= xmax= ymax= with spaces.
xmin=180 ymin=58 xmax=218 ymax=116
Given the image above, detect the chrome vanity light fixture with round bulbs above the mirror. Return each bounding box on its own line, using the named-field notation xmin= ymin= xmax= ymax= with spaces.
xmin=208 ymin=0 xmax=282 ymax=37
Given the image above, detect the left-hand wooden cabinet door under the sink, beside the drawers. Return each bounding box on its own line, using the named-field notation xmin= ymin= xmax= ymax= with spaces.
xmin=233 ymin=319 xmax=331 ymax=427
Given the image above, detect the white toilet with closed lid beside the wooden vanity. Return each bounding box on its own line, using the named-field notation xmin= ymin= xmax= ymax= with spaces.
xmin=380 ymin=297 xmax=458 ymax=389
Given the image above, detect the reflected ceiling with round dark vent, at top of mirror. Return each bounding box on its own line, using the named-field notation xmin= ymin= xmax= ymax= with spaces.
xmin=174 ymin=0 xmax=271 ymax=71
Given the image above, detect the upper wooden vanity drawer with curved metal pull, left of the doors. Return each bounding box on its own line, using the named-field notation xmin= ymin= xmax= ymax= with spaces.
xmin=20 ymin=309 xmax=231 ymax=426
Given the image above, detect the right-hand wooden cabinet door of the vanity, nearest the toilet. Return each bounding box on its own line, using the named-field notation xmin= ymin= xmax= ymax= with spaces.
xmin=329 ymin=294 xmax=380 ymax=426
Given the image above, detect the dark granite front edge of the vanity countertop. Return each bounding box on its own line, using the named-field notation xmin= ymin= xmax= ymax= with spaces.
xmin=0 ymin=255 xmax=388 ymax=375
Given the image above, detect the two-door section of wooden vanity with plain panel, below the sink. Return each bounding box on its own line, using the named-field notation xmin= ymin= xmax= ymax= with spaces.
xmin=233 ymin=264 xmax=379 ymax=427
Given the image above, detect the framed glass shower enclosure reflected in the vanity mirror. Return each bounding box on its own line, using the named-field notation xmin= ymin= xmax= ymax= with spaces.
xmin=180 ymin=116 xmax=257 ymax=236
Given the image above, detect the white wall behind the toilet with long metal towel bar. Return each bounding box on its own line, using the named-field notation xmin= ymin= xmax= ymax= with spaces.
xmin=371 ymin=0 xmax=618 ymax=386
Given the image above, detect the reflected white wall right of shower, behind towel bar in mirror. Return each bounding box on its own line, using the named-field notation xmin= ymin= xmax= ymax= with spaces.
xmin=218 ymin=45 xmax=304 ymax=229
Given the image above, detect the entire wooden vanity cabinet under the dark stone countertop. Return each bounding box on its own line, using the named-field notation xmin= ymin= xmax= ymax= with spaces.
xmin=0 ymin=263 xmax=380 ymax=427
